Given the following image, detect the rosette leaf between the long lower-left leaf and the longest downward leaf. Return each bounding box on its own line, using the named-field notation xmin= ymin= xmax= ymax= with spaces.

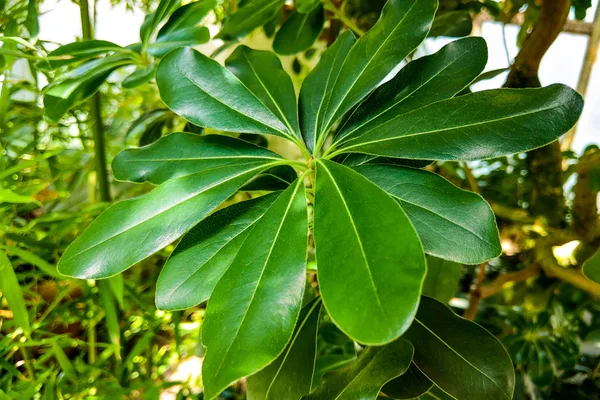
xmin=156 ymin=195 xmax=277 ymax=310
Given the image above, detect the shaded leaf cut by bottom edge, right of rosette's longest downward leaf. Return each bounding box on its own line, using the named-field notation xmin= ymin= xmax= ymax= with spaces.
xmin=246 ymin=297 xmax=321 ymax=400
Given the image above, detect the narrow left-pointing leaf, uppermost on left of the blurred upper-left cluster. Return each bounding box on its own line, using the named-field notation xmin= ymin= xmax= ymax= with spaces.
xmin=41 ymin=40 xmax=127 ymax=69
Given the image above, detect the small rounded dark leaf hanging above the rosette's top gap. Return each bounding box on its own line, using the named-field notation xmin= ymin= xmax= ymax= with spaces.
xmin=273 ymin=5 xmax=325 ymax=55
